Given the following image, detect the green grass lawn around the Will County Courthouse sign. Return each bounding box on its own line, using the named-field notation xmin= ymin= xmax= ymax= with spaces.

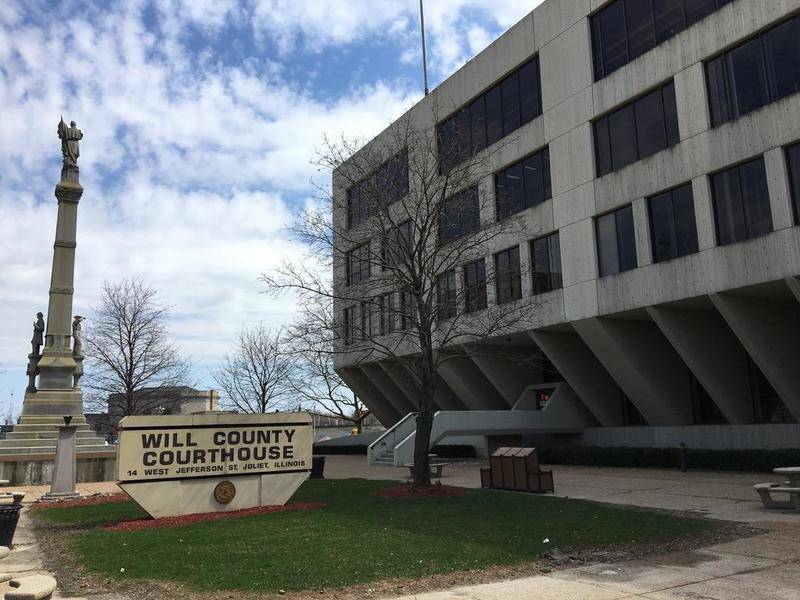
xmin=34 ymin=479 xmax=713 ymax=592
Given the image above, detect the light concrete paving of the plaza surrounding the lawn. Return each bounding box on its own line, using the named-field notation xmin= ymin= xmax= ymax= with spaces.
xmin=3 ymin=456 xmax=800 ymax=600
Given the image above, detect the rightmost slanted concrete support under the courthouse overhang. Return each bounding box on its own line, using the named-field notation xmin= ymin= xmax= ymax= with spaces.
xmin=711 ymin=294 xmax=800 ymax=421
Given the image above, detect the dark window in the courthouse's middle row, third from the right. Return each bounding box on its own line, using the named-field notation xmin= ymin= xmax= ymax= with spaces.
xmin=495 ymin=148 xmax=552 ymax=221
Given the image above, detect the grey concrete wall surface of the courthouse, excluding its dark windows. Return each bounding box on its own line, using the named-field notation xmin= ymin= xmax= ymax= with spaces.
xmin=334 ymin=0 xmax=800 ymax=449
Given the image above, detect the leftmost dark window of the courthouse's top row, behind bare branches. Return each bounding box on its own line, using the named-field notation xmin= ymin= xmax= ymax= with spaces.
xmin=347 ymin=150 xmax=408 ymax=229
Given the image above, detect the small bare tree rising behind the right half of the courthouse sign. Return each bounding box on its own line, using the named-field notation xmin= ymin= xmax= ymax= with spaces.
xmin=212 ymin=323 xmax=294 ymax=413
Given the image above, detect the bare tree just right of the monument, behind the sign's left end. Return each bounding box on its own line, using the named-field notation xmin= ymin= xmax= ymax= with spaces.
xmin=84 ymin=279 xmax=191 ymax=418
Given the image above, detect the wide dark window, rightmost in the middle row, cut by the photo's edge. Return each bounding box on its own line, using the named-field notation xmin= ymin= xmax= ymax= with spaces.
xmin=706 ymin=16 xmax=800 ymax=127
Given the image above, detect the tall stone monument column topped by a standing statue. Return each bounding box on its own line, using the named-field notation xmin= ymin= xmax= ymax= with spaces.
xmin=22 ymin=118 xmax=83 ymax=416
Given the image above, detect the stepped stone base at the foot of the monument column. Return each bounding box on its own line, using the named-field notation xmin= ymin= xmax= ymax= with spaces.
xmin=0 ymin=415 xmax=109 ymax=456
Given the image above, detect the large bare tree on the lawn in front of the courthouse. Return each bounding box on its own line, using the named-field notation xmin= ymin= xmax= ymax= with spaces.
xmin=262 ymin=110 xmax=533 ymax=486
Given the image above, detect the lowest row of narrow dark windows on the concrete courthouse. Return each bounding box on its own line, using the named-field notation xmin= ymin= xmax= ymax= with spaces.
xmin=354 ymin=143 xmax=800 ymax=290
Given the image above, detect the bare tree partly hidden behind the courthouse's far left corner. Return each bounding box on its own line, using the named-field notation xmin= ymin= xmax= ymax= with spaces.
xmin=286 ymin=300 xmax=371 ymax=433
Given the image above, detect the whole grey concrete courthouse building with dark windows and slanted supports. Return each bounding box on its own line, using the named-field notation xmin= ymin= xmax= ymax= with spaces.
xmin=334 ymin=0 xmax=800 ymax=462
